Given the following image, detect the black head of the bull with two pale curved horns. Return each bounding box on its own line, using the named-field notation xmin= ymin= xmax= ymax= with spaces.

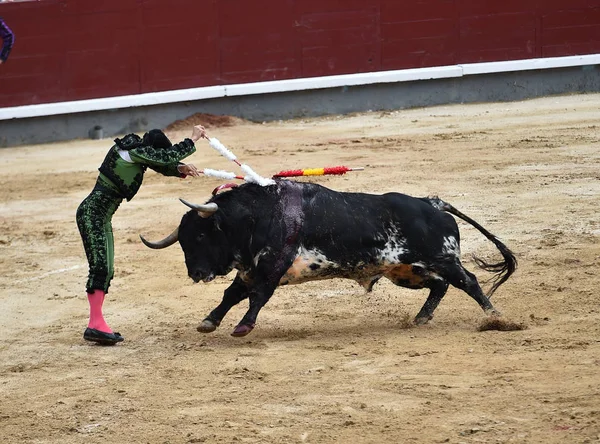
xmin=140 ymin=199 xmax=234 ymax=282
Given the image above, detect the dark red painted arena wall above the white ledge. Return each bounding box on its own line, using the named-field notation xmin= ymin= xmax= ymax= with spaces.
xmin=0 ymin=0 xmax=600 ymax=107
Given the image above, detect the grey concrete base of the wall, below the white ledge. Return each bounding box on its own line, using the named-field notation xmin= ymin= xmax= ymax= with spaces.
xmin=0 ymin=65 xmax=600 ymax=147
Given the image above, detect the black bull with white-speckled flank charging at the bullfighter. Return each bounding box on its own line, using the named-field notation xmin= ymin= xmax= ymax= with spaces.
xmin=140 ymin=180 xmax=517 ymax=336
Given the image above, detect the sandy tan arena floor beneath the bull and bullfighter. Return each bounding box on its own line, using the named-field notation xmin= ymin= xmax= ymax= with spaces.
xmin=0 ymin=95 xmax=600 ymax=444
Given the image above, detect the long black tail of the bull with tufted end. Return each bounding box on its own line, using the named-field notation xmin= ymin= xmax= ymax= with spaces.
xmin=425 ymin=197 xmax=517 ymax=298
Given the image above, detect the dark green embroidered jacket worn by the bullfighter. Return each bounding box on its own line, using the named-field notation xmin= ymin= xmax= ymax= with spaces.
xmin=98 ymin=139 xmax=196 ymax=201
